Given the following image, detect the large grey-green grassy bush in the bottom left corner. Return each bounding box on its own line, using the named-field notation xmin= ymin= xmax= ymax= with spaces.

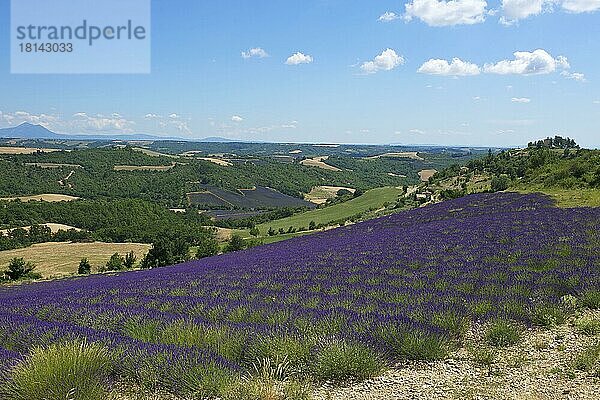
xmin=7 ymin=342 xmax=112 ymax=400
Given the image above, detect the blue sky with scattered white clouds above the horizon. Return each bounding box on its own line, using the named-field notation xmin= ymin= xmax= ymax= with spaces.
xmin=0 ymin=0 xmax=600 ymax=147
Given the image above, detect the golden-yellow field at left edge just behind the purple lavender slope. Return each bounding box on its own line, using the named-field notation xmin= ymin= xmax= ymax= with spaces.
xmin=0 ymin=242 xmax=152 ymax=278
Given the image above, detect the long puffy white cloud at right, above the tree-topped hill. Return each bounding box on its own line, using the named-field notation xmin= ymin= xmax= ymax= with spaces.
xmin=483 ymin=49 xmax=570 ymax=75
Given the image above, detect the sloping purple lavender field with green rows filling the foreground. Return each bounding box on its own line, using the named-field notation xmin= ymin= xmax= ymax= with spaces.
xmin=0 ymin=193 xmax=600 ymax=396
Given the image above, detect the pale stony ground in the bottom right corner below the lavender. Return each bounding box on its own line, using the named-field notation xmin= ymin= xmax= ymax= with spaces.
xmin=314 ymin=312 xmax=600 ymax=400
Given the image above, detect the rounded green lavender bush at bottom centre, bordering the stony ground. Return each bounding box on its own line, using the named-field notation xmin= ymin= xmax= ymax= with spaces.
xmin=312 ymin=340 xmax=385 ymax=381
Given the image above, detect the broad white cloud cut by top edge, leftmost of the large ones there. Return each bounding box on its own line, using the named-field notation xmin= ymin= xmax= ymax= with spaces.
xmin=404 ymin=0 xmax=487 ymax=26
